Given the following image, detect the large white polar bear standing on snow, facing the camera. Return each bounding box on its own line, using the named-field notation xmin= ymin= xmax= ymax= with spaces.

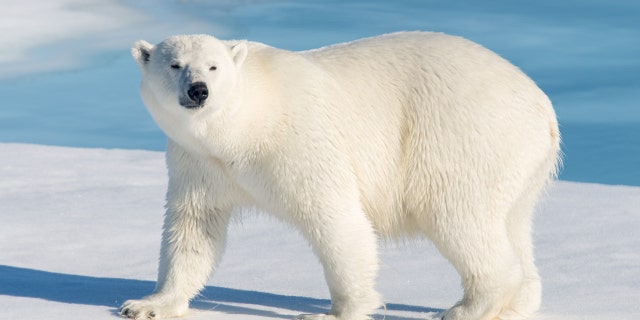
xmin=120 ymin=32 xmax=560 ymax=320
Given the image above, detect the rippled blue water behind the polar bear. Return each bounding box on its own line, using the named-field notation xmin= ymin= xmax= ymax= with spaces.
xmin=0 ymin=0 xmax=640 ymax=185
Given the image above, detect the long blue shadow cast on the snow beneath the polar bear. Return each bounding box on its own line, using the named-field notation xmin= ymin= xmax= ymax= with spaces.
xmin=0 ymin=265 xmax=442 ymax=320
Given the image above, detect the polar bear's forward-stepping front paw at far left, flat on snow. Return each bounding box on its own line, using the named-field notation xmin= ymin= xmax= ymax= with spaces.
xmin=120 ymin=299 xmax=188 ymax=320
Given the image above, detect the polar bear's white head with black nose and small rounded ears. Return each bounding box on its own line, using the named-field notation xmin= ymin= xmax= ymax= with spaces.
xmin=131 ymin=35 xmax=247 ymax=114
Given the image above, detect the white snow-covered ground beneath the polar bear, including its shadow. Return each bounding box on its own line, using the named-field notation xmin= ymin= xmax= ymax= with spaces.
xmin=0 ymin=144 xmax=640 ymax=320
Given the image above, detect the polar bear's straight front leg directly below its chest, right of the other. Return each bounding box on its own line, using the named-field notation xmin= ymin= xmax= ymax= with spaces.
xmin=296 ymin=206 xmax=382 ymax=320
